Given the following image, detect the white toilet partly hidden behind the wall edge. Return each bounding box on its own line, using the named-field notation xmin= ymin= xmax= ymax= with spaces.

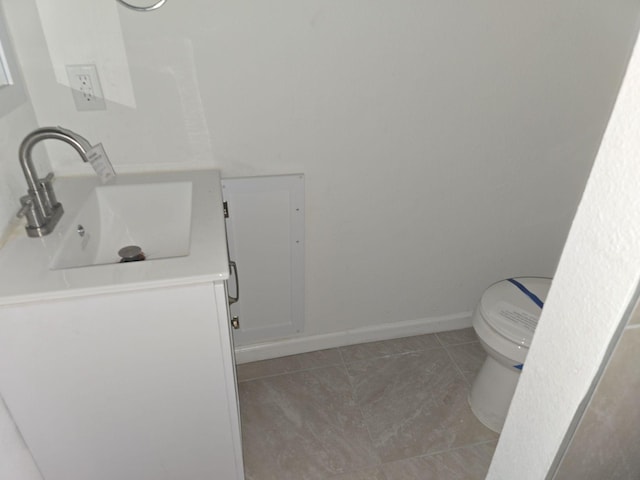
xmin=469 ymin=277 xmax=551 ymax=433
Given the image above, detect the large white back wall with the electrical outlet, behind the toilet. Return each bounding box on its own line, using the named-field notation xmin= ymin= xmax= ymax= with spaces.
xmin=5 ymin=0 xmax=638 ymax=344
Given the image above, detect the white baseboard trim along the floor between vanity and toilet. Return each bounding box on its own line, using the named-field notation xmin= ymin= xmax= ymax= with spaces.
xmin=235 ymin=312 xmax=471 ymax=363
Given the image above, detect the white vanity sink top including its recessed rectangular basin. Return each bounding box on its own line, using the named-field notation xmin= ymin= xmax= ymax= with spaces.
xmin=0 ymin=169 xmax=229 ymax=305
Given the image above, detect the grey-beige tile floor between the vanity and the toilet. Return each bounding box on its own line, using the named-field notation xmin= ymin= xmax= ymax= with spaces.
xmin=237 ymin=328 xmax=498 ymax=480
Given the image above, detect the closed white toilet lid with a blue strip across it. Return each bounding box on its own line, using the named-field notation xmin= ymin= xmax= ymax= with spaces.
xmin=480 ymin=277 xmax=551 ymax=347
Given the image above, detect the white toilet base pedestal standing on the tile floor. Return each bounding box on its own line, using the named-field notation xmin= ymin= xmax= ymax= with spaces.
xmin=469 ymin=355 xmax=520 ymax=433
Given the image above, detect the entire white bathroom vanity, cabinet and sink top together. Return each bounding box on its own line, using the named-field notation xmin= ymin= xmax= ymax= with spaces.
xmin=0 ymin=170 xmax=244 ymax=480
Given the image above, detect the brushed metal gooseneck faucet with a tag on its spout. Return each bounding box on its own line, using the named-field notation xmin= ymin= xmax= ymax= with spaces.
xmin=18 ymin=127 xmax=91 ymax=237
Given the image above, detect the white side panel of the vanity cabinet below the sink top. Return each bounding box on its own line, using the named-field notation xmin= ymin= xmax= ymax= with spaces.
xmin=0 ymin=281 xmax=244 ymax=480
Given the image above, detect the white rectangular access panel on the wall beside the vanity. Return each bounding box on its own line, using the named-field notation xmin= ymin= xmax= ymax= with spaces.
xmin=222 ymin=175 xmax=304 ymax=346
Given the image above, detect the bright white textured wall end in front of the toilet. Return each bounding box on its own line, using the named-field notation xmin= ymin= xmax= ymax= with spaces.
xmin=487 ymin=29 xmax=640 ymax=480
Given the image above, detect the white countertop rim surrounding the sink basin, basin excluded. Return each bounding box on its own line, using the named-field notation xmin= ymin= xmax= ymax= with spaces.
xmin=0 ymin=170 xmax=229 ymax=305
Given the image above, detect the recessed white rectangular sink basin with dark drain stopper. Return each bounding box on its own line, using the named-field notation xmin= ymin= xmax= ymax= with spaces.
xmin=49 ymin=181 xmax=192 ymax=270
